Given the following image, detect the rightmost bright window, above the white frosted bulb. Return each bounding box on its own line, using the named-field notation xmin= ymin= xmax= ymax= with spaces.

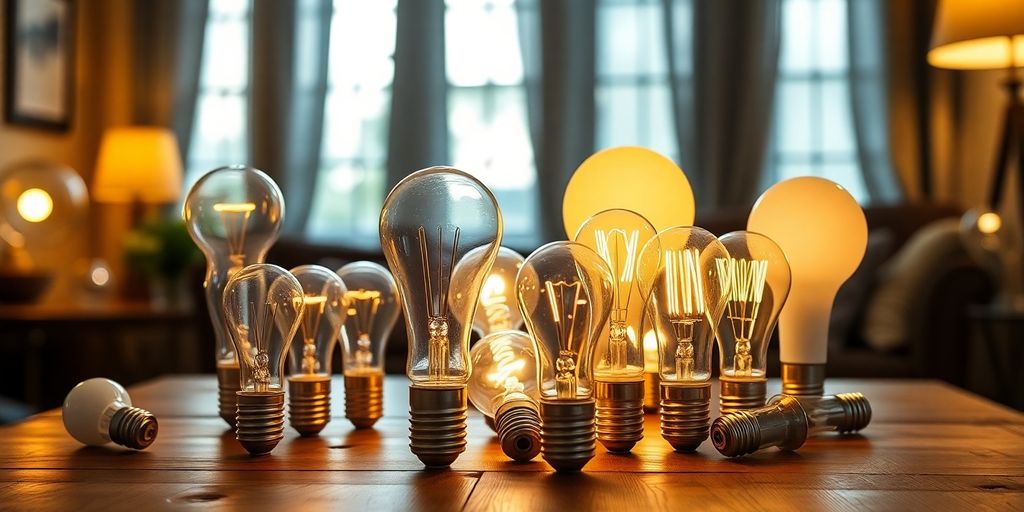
xmin=769 ymin=0 xmax=867 ymax=202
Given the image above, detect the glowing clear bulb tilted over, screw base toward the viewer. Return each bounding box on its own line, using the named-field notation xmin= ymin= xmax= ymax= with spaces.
xmin=469 ymin=329 xmax=541 ymax=462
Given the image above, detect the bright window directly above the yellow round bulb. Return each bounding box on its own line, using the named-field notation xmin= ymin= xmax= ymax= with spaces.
xmin=594 ymin=0 xmax=690 ymax=162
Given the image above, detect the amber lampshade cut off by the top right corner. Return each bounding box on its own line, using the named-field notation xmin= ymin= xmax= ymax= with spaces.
xmin=928 ymin=0 xmax=1024 ymax=70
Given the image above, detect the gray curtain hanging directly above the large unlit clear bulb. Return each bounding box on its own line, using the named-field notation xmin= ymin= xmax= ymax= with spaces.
xmin=387 ymin=0 xmax=449 ymax=187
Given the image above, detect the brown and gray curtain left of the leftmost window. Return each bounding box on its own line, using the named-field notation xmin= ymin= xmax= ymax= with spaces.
xmin=131 ymin=0 xmax=207 ymax=162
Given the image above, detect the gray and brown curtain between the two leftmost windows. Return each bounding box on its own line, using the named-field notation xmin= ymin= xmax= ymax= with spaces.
xmin=249 ymin=0 xmax=332 ymax=233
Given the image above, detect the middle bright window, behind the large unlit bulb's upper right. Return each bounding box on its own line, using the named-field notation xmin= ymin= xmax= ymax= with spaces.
xmin=444 ymin=0 xmax=538 ymax=245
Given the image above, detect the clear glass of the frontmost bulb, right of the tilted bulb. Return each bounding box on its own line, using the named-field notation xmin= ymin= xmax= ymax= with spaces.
xmin=516 ymin=242 xmax=614 ymax=399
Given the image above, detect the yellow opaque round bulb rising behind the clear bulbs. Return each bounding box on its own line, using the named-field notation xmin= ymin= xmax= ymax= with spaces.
xmin=562 ymin=146 xmax=694 ymax=237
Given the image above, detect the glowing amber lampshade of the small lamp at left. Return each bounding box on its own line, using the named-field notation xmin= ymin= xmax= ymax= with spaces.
xmin=92 ymin=126 xmax=181 ymax=204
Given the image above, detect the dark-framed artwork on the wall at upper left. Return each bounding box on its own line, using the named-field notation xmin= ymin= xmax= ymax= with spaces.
xmin=4 ymin=0 xmax=75 ymax=131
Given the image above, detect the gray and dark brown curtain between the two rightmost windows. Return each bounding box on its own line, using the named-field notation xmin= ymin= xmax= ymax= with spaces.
xmin=664 ymin=0 xmax=781 ymax=210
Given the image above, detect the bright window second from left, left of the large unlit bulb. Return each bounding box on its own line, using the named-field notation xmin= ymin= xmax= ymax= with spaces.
xmin=307 ymin=0 xmax=396 ymax=240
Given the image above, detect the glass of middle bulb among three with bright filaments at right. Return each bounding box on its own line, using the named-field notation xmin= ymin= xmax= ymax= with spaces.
xmin=638 ymin=226 xmax=729 ymax=383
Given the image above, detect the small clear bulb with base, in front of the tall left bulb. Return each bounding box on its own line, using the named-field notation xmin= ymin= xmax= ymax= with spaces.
xmin=222 ymin=263 xmax=305 ymax=455
